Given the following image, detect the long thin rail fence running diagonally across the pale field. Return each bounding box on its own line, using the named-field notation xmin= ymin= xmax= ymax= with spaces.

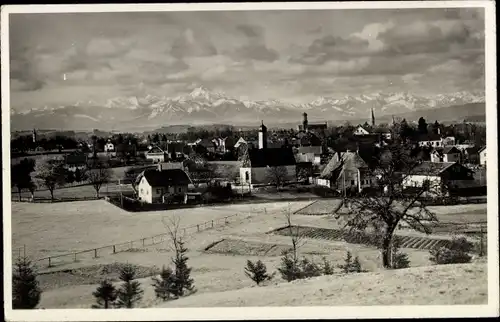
xmin=22 ymin=214 xmax=238 ymax=267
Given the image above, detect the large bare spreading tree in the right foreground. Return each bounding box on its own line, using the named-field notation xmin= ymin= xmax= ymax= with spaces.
xmin=345 ymin=143 xmax=437 ymax=268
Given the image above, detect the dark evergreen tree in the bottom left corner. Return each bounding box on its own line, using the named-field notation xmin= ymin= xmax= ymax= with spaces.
xmin=12 ymin=256 xmax=42 ymax=310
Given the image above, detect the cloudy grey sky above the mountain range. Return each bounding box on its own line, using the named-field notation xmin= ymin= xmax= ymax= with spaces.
xmin=9 ymin=8 xmax=485 ymax=111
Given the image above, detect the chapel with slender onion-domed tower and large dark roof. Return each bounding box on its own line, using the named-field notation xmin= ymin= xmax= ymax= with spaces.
xmin=240 ymin=123 xmax=297 ymax=189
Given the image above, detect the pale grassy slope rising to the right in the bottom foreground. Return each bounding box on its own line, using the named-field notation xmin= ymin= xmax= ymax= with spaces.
xmin=161 ymin=263 xmax=488 ymax=307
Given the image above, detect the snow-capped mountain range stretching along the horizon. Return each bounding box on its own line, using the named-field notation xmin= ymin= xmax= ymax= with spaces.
xmin=11 ymin=87 xmax=484 ymax=130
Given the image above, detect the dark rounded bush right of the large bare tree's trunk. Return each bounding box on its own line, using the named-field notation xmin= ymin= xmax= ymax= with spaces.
xmin=429 ymin=237 xmax=474 ymax=265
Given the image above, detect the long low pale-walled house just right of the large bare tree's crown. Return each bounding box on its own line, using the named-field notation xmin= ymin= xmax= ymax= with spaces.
xmin=402 ymin=161 xmax=474 ymax=195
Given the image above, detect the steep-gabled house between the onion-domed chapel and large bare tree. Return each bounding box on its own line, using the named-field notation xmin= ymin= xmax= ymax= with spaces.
xmin=317 ymin=150 xmax=376 ymax=192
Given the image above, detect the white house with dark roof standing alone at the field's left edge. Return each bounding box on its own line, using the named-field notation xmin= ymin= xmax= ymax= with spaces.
xmin=136 ymin=169 xmax=191 ymax=203
